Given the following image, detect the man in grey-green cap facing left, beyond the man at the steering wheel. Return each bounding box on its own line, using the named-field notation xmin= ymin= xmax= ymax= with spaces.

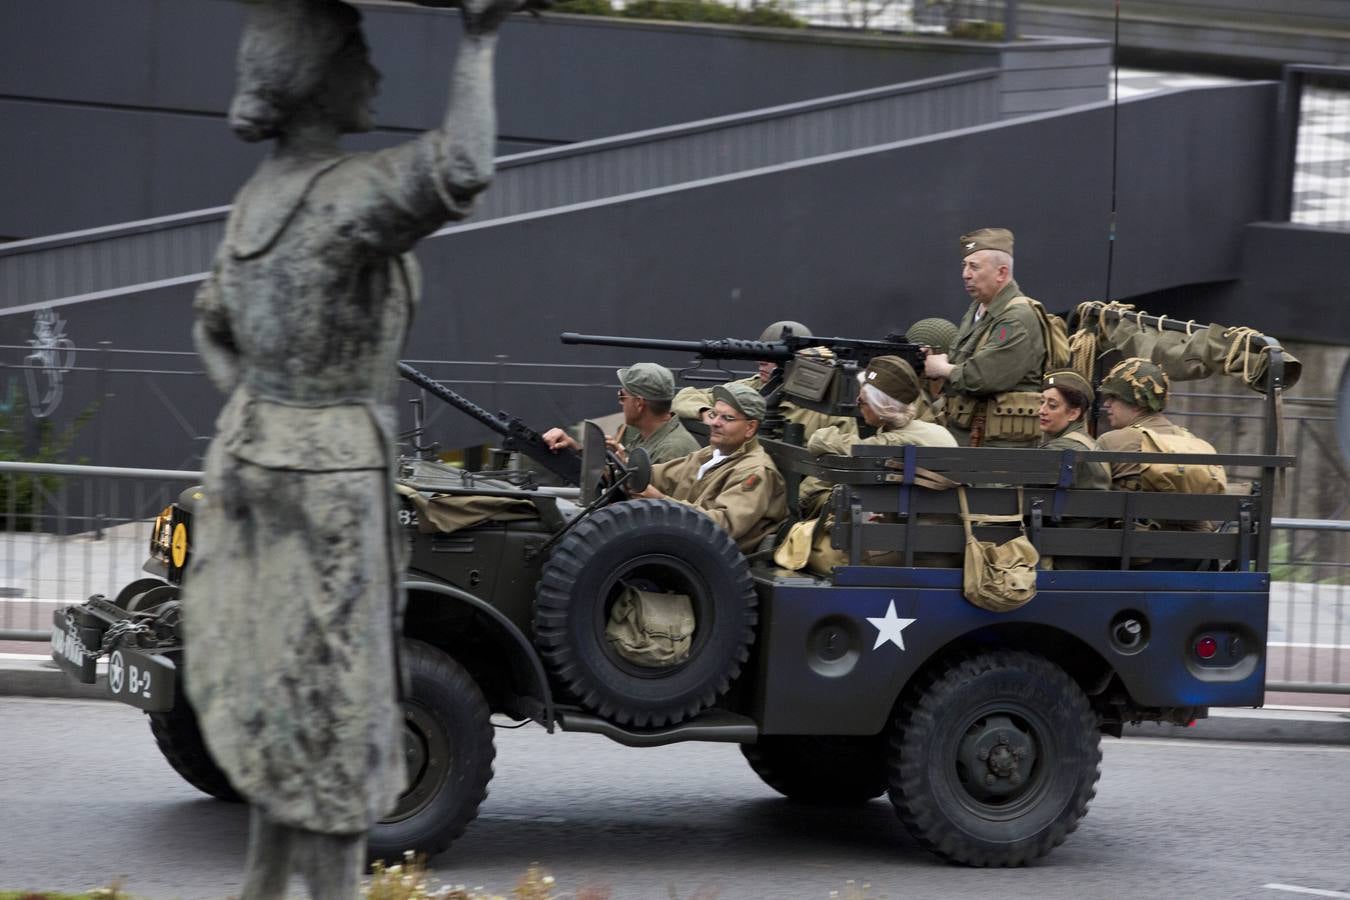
xmin=544 ymin=363 xmax=698 ymax=463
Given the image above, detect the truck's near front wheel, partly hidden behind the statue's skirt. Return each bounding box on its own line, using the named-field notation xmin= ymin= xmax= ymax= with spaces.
xmin=366 ymin=641 xmax=495 ymax=862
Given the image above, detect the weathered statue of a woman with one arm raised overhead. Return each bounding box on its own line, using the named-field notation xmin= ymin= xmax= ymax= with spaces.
xmin=184 ymin=0 xmax=521 ymax=900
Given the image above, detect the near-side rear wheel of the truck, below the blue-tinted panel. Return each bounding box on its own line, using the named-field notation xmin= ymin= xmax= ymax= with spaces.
xmin=890 ymin=650 xmax=1102 ymax=866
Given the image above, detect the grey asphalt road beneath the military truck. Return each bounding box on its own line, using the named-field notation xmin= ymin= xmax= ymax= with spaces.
xmin=0 ymin=698 xmax=1350 ymax=900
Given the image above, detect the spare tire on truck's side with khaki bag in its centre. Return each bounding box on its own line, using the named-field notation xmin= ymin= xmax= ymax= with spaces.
xmin=535 ymin=501 xmax=759 ymax=726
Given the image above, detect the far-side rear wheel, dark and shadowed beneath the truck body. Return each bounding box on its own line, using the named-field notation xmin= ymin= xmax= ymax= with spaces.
xmin=741 ymin=734 xmax=887 ymax=804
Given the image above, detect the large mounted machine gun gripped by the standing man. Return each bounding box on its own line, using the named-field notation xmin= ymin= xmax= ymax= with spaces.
xmin=562 ymin=332 xmax=923 ymax=416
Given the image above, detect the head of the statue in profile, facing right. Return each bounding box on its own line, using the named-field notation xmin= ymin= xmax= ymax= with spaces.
xmin=230 ymin=0 xmax=379 ymax=140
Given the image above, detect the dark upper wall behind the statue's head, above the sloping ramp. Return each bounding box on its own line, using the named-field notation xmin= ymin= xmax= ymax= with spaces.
xmin=0 ymin=0 xmax=1110 ymax=239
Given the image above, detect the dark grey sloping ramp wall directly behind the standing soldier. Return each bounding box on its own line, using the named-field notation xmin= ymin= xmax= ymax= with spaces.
xmin=0 ymin=84 xmax=1285 ymax=466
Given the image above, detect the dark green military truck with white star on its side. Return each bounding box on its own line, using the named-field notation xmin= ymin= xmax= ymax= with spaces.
xmin=53 ymin=317 xmax=1292 ymax=866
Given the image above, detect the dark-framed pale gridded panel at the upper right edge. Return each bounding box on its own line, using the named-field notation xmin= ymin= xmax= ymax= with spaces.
xmin=1272 ymin=65 xmax=1350 ymax=231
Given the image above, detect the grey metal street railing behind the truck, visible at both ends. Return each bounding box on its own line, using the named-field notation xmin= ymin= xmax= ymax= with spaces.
xmin=0 ymin=461 xmax=1350 ymax=694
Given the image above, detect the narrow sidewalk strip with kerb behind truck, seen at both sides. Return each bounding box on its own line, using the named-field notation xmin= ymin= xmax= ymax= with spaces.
xmin=0 ymin=658 xmax=1350 ymax=745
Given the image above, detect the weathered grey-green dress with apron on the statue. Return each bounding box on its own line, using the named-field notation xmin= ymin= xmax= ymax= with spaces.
xmin=184 ymin=132 xmax=482 ymax=834
